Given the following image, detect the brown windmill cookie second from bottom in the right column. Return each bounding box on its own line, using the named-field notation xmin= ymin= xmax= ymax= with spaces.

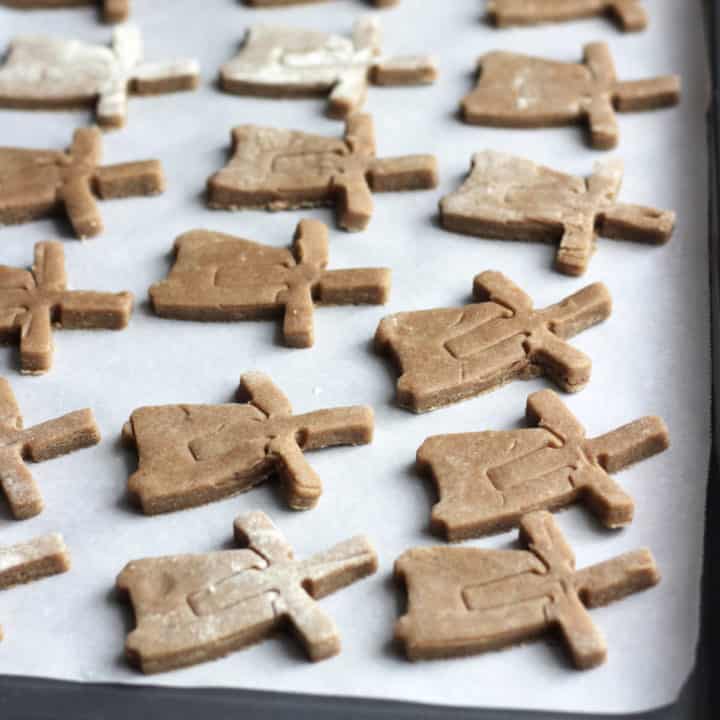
xmin=417 ymin=390 xmax=670 ymax=541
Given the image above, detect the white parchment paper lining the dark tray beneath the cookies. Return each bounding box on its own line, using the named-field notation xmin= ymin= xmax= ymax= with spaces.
xmin=0 ymin=0 xmax=710 ymax=712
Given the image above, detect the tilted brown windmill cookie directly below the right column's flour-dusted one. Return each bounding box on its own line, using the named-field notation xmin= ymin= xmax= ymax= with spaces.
xmin=375 ymin=271 xmax=612 ymax=413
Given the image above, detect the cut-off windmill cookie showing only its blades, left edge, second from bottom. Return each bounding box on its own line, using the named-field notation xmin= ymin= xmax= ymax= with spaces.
xmin=0 ymin=376 xmax=100 ymax=520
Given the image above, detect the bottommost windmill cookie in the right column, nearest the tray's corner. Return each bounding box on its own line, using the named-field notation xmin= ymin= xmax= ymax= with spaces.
xmin=395 ymin=511 xmax=660 ymax=669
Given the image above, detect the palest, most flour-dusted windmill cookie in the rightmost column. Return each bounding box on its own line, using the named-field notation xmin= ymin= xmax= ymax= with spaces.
xmin=440 ymin=150 xmax=675 ymax=275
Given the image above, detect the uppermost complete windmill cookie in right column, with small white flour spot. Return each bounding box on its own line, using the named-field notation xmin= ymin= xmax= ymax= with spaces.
xmin=461 ymin=43 xmax=680 ymax=149
